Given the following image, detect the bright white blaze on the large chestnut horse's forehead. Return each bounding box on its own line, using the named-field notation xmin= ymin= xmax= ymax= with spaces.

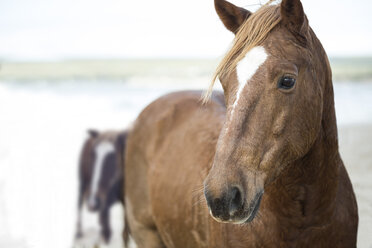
xmin=231 ymin=46 xmax=267 ymax=116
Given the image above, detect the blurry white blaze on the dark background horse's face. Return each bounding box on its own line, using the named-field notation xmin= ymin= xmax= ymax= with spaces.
xmin=89 ymin=142 xmax=115 ymax=204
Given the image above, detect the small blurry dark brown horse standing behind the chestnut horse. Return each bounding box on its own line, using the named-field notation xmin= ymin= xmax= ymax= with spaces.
xmin=76 ymin=130 xmax=127 ymax=243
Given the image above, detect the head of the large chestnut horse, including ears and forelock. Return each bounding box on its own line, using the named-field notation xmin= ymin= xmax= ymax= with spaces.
xmin=204 ymin=0 xmax=335 ymax=224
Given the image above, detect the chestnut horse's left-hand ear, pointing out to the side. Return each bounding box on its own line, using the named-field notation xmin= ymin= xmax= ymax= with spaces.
xmin=214 ymin=0 xmax=251 ymax=34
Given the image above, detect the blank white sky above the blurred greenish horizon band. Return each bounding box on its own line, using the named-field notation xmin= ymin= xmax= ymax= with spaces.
xmin=0 ymin=0 xmax=372 ymax=61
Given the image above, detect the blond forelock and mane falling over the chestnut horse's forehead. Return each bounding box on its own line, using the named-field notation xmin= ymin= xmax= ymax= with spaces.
xmin=203 ymin=1 xmax=281 ymax=103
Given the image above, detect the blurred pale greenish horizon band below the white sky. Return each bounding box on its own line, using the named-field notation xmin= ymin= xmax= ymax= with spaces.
xmin=0 ymin=56 xmax=372 ymax=83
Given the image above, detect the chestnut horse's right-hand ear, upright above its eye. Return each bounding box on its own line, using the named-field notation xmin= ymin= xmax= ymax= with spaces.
xmin=280 ymin=0 xmax=306 ymax=41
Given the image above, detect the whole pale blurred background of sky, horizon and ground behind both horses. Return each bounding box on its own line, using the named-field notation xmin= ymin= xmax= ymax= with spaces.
xmin=0 ymin=0 xmax=372 ymax=248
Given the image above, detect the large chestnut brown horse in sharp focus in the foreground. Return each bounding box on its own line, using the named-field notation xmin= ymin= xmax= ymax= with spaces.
xmin=125 ymin=0 xmax=358 ymax=248
